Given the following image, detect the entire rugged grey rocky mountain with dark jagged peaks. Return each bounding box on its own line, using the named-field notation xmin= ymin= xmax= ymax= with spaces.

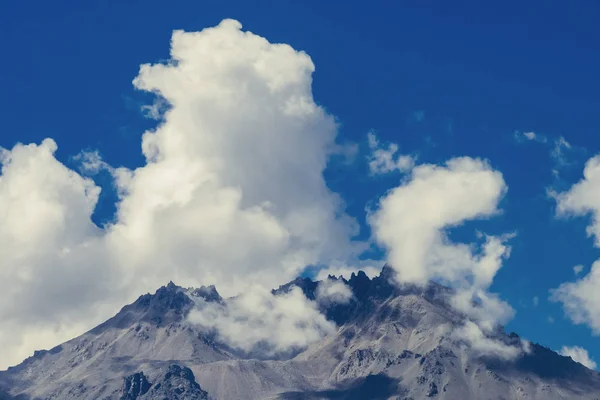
xmin=0 ymin=267 xmax=600 ymax=400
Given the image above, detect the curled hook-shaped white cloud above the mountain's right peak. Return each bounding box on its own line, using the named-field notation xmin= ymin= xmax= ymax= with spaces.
xmin=369 ymin=157 xmax=506 ymax=286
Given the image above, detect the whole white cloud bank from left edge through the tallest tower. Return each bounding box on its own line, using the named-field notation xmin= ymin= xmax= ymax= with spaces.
xmin=0 ymin=20 xmax=361 ymax=368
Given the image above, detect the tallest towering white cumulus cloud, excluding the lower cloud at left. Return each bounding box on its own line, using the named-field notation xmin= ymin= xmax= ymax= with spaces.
xmin=111 ymin=20 xmax=364 ymax=294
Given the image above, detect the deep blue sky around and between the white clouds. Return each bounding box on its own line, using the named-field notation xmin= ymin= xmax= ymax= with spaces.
xmin=0 ymin=0 xmax=600 ymax=368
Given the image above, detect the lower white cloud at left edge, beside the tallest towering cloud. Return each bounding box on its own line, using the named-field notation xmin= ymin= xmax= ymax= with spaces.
xmin=0 ymin=139 xmax=120 ymax=368
